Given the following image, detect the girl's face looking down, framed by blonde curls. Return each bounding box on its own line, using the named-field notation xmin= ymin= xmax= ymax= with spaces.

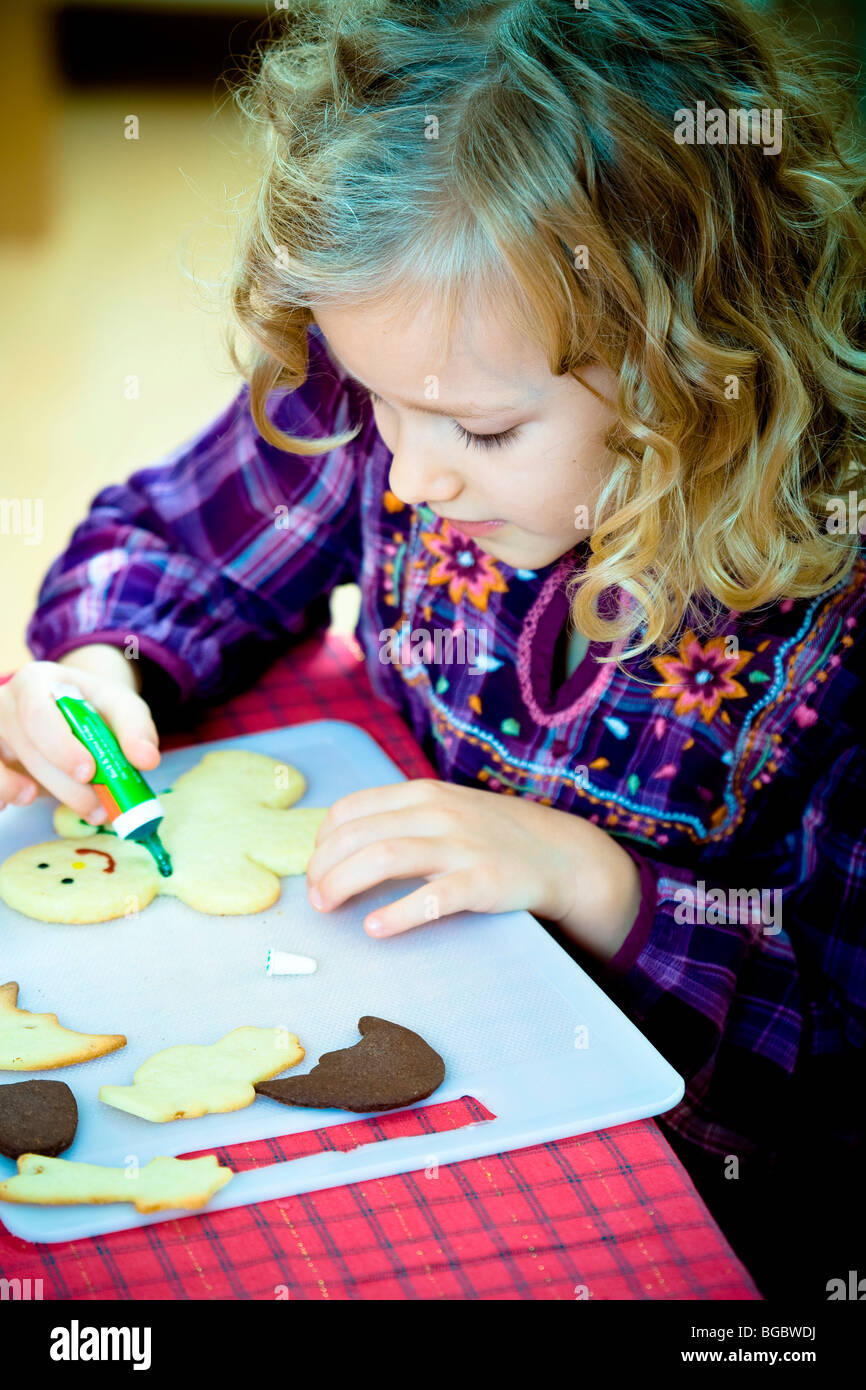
xmin=314 ymin=296 xmax=616 ymax=570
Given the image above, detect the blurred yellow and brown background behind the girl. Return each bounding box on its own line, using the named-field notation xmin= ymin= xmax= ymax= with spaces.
xmin=0 ymin=0 xmax=866 ymax=673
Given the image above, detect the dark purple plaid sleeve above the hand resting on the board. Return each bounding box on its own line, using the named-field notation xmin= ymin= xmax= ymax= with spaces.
xmin=605 ymin=742 xmax=866 ymax=1152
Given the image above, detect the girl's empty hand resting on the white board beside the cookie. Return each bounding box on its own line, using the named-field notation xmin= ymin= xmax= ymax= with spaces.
xmin=307 ymin=777 xmax=639 ymax=960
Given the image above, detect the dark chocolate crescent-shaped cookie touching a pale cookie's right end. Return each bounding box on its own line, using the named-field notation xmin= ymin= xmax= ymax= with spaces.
xmin=256 ymin=1015 xmax=445 ymax=1111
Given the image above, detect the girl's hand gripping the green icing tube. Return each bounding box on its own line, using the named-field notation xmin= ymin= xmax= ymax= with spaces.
xmin=0 ymin=652 xmax=160 ymax=826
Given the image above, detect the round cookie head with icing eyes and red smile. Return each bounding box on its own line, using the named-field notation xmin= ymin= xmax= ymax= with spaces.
xmin=0 ymin=840 xmax=157 ymax=923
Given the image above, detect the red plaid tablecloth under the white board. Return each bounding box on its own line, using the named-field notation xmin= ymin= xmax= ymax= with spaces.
xmin=0 ymin=635 xmax=760 ymax=1300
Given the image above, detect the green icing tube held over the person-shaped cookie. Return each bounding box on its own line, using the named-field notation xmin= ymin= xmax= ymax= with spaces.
xmin=51 ymin=684 xmax=171 ymax=878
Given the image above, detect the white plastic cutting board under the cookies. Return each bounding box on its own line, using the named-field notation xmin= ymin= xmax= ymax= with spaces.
xmin=0 ymin=720 xmax=684 ymax=1241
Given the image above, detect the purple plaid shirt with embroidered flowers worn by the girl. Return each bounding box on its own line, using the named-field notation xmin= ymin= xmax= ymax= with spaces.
xmin=28 ymin=328 xmax=866 ymax=1155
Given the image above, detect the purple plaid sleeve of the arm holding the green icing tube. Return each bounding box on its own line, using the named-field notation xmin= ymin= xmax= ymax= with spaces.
xmin=28 ymin=335 xmax=361 ymax=698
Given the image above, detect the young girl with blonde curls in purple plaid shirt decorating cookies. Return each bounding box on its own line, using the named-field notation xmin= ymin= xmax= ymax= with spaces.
xmin=0 ymin=0 xmax=866 ymax=1297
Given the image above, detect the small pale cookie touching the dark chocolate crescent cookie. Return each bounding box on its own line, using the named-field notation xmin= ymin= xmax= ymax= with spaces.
xmin=99 ymin=1029 xmax=304 ymax=1122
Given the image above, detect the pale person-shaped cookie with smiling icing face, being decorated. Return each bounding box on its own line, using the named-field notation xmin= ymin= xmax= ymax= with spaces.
xmin=0 ymin=749 xmax=325 ymax=923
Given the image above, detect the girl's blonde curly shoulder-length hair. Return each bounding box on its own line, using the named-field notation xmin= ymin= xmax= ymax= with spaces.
xmin=229 ymin=0 xmax=866 ymax=660
